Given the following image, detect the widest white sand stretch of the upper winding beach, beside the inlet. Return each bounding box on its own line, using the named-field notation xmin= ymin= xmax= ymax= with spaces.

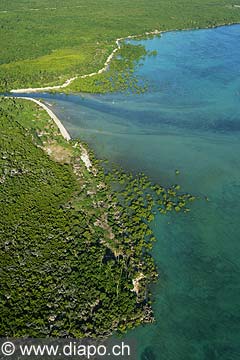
xmin=11 ymin=30 xmax=161 ymax=94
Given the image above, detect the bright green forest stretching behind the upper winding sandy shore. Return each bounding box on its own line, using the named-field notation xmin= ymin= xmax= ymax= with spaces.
xmin=0 ymin=0 xmax=240 ymax=90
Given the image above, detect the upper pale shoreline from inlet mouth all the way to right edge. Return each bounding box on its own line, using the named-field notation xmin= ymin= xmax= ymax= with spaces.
xmin=10 ymin=22 xmax=239 ymax=94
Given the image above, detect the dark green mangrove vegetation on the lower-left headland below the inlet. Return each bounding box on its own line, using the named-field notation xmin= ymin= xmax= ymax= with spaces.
xmin=0 ymin=98 xmax=194 ymax=337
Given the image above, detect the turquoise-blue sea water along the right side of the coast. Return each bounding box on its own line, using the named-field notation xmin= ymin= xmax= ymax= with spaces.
xmin=16 ymin=25 xmax=240 ymax=360
